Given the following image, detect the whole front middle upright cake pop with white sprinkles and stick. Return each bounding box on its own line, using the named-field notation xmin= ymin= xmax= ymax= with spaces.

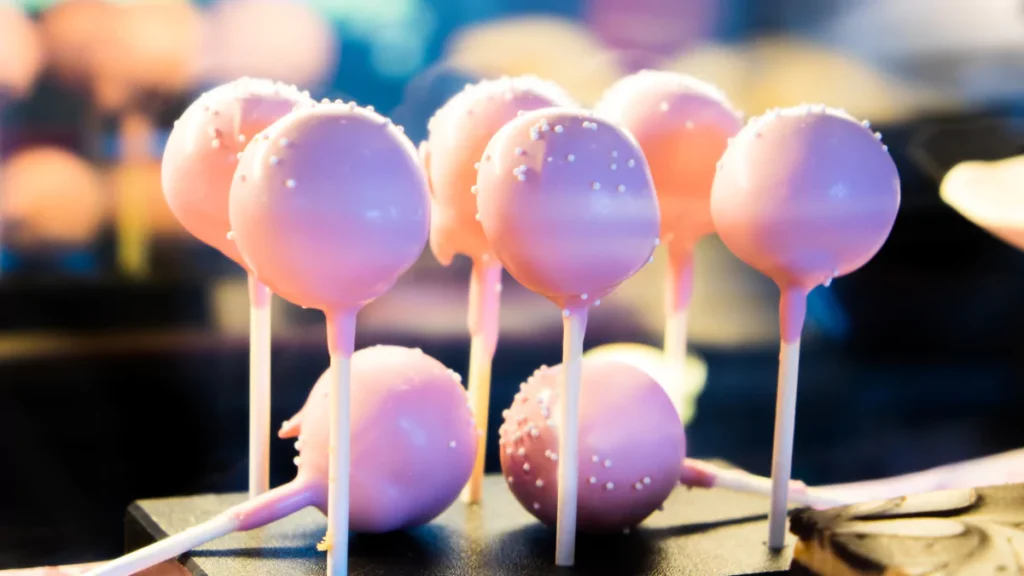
xmin=476 ymin=108 xmax=658 ymax=566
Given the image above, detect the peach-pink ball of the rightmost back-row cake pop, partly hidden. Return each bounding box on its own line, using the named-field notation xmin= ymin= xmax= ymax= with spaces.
xmin=595 ymin=70 xmax=743 ymax=245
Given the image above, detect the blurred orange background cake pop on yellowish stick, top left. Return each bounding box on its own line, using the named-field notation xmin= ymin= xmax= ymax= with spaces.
xmin=92 ymin=0 xmax=203 ymax=277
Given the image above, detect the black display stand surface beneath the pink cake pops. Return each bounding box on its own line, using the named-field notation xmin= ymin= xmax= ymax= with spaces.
xmin=125 ymin=476 xmax=795 ymax=576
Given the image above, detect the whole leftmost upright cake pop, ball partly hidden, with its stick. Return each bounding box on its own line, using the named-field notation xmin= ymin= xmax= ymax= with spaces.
xmin=162 ymin=78 xmax=311 ymax=496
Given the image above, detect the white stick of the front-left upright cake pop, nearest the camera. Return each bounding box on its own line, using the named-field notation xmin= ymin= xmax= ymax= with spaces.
xmin=327 ymin=311 xmax=355 ymax=576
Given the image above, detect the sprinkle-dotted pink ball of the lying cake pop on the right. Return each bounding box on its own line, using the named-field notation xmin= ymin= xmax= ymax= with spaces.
xmin=499 ymin=357 xmax=686 ymax=532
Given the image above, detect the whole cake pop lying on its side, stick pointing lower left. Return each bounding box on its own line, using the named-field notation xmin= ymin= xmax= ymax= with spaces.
xmin=87 ymin=346 xmax=477 ymax=576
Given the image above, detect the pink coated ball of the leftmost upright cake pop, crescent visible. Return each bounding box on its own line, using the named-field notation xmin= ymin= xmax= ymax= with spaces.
xmin=161 ymin=78 xmax=310 ymax=266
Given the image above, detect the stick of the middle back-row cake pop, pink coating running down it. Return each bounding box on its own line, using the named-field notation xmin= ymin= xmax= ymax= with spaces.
xmin=462 ymin=256 xmax=502 ymax=504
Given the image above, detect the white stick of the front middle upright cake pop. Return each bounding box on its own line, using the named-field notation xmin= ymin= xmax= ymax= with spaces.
xmin=555 ymin=306 xmax=588 ymax=566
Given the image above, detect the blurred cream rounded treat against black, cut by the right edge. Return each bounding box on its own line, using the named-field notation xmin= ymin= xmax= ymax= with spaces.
xmin=939 ymin=156 xmax=1024 ymax=250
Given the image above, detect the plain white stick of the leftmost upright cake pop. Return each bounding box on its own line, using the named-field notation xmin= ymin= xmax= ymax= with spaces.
xmin=249 ymin=274 xmax=270 ymax=498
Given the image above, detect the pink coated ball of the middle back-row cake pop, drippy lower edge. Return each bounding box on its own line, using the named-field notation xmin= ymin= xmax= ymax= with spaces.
xmin=420 ymin=76 xmax=578 ymax=265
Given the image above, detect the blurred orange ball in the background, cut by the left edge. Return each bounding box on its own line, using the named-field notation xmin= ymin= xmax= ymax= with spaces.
xmin=0 ymin=147 xmax=106 ymax=248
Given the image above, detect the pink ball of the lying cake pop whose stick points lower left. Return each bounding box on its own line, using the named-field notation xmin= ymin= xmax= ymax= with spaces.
xmin=282 ymin=346 xmax=477 ymax=532
